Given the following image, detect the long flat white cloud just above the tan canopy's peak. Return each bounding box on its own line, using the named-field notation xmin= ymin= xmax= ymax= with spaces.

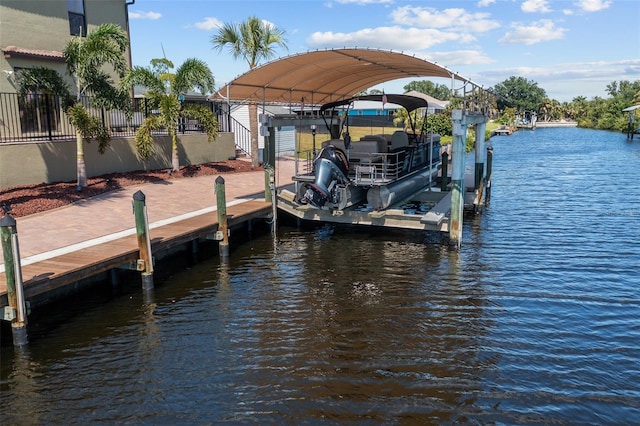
xmin=307 ymin=26 xmax=474 ymax=51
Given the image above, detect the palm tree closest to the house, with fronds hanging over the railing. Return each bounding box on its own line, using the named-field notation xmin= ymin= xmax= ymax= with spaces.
xmin=63 ymin=24 xmax=130 ymax=190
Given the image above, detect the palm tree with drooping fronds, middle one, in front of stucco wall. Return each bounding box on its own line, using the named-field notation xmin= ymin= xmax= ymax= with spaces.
xmin=121 ymin=58 xmax=218 ymax=171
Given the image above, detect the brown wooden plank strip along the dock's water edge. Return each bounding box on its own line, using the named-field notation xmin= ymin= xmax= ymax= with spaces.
xmin=0 ymin=200 xmax=272 ymax=307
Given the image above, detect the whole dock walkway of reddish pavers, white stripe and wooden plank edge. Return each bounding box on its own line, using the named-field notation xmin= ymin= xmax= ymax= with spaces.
xmin=0 ymin=158 xmax=293 ymax=309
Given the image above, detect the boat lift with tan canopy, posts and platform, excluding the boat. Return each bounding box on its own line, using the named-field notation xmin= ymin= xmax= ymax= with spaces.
xmin=211 ymin=48 xmax=492 ymax=247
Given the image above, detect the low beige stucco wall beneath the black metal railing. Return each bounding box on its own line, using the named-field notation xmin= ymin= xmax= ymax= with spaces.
xmin=0 ymin=133 xmax=235 ymax=189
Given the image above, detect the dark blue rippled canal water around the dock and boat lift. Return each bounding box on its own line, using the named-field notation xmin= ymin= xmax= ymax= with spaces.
xmin=0 ymin=128 xmax=640 ymax=425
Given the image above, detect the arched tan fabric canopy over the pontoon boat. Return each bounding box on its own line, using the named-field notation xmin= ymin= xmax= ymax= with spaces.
xmin=213 ymin=49 xmax=469 ymax=105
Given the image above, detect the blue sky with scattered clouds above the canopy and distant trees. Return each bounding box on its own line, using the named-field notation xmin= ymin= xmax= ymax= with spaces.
xmin=129 ymin=0 xmax=640 ymax=102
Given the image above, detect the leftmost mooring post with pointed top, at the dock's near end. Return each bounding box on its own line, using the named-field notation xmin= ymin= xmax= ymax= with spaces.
xmin=0 ymin=213 xmax=29 ymax=346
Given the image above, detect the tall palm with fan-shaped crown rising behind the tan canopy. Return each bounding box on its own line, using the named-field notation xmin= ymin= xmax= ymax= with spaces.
xmin=211 ymin=16 xmax=286 ymax=167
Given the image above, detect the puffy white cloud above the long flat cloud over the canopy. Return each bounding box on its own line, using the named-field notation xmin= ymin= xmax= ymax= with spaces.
xmin=391 ymin=6 xmax=500 ymax=33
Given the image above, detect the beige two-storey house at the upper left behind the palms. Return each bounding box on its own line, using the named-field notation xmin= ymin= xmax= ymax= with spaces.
xmin=0 ymin=0 xmax=134 ymax=140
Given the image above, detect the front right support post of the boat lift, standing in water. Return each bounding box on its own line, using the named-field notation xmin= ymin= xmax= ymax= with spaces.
xmin=449 ymin=109 xmax=467 ymax=248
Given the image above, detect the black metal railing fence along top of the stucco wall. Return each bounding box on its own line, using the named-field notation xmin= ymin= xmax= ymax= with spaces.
xmin=0 ymin=93 xmax=238 ymax=144
